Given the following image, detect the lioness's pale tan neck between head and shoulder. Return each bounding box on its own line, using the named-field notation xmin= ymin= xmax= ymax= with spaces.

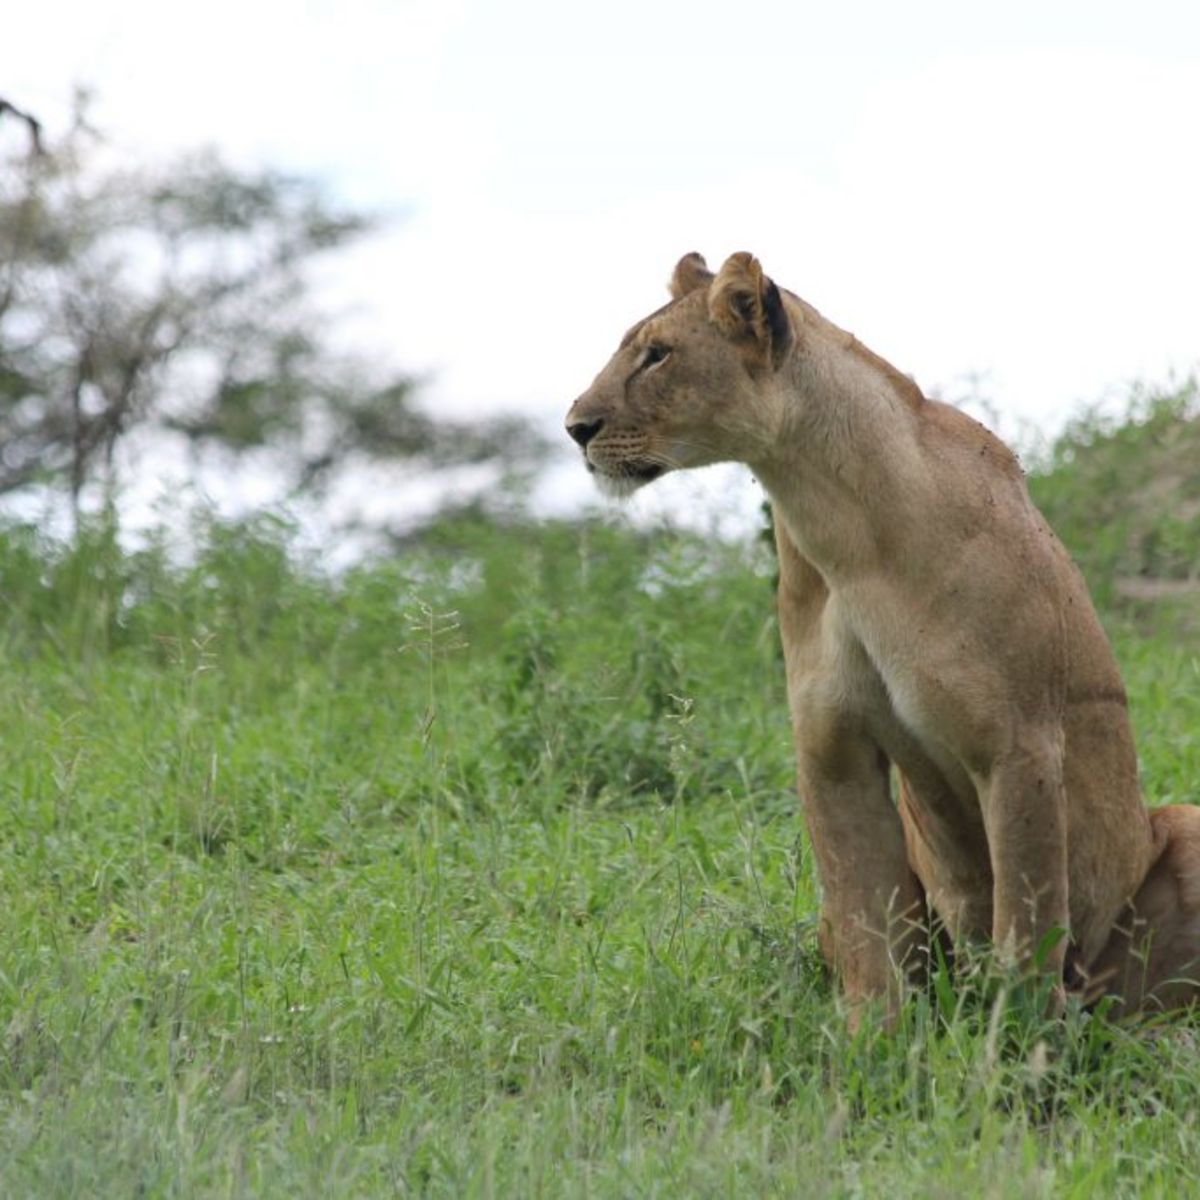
xmin=752 ymin=312 xmax=930 ymax=580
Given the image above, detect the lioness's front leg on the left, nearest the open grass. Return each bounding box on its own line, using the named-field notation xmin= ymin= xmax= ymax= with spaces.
xmin=799 ymin=742 xmax=928 ymax=1028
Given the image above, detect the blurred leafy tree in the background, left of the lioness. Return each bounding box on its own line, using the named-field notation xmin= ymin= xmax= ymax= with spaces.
xmin=0 ymin=106 xmax=536 ymax=525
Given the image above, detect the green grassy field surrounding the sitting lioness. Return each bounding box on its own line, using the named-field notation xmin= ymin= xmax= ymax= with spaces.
xmin=0 ymin=393 xmax=1200 ymax=1196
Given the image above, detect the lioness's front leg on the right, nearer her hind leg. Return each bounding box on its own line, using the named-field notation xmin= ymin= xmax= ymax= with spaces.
xmin=980 ymin=731 xmax=1070 ymax=995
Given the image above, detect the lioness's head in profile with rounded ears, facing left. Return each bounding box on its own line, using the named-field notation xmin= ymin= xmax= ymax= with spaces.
xmin=566 ymin=253 xmax=793 ymax=496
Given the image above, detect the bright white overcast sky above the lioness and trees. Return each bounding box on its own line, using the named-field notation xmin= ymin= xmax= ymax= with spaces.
xmin=0 ymin=0 xmax=1200 ymax=525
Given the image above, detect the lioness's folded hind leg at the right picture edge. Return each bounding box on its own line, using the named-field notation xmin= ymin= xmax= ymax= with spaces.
xmin=1087 ymin=804 xmax=1200 ymax=1013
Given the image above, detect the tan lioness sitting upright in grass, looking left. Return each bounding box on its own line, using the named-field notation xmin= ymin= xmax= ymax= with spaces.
xmin=566 ymin=253 xmax=1200 ymax=1024
